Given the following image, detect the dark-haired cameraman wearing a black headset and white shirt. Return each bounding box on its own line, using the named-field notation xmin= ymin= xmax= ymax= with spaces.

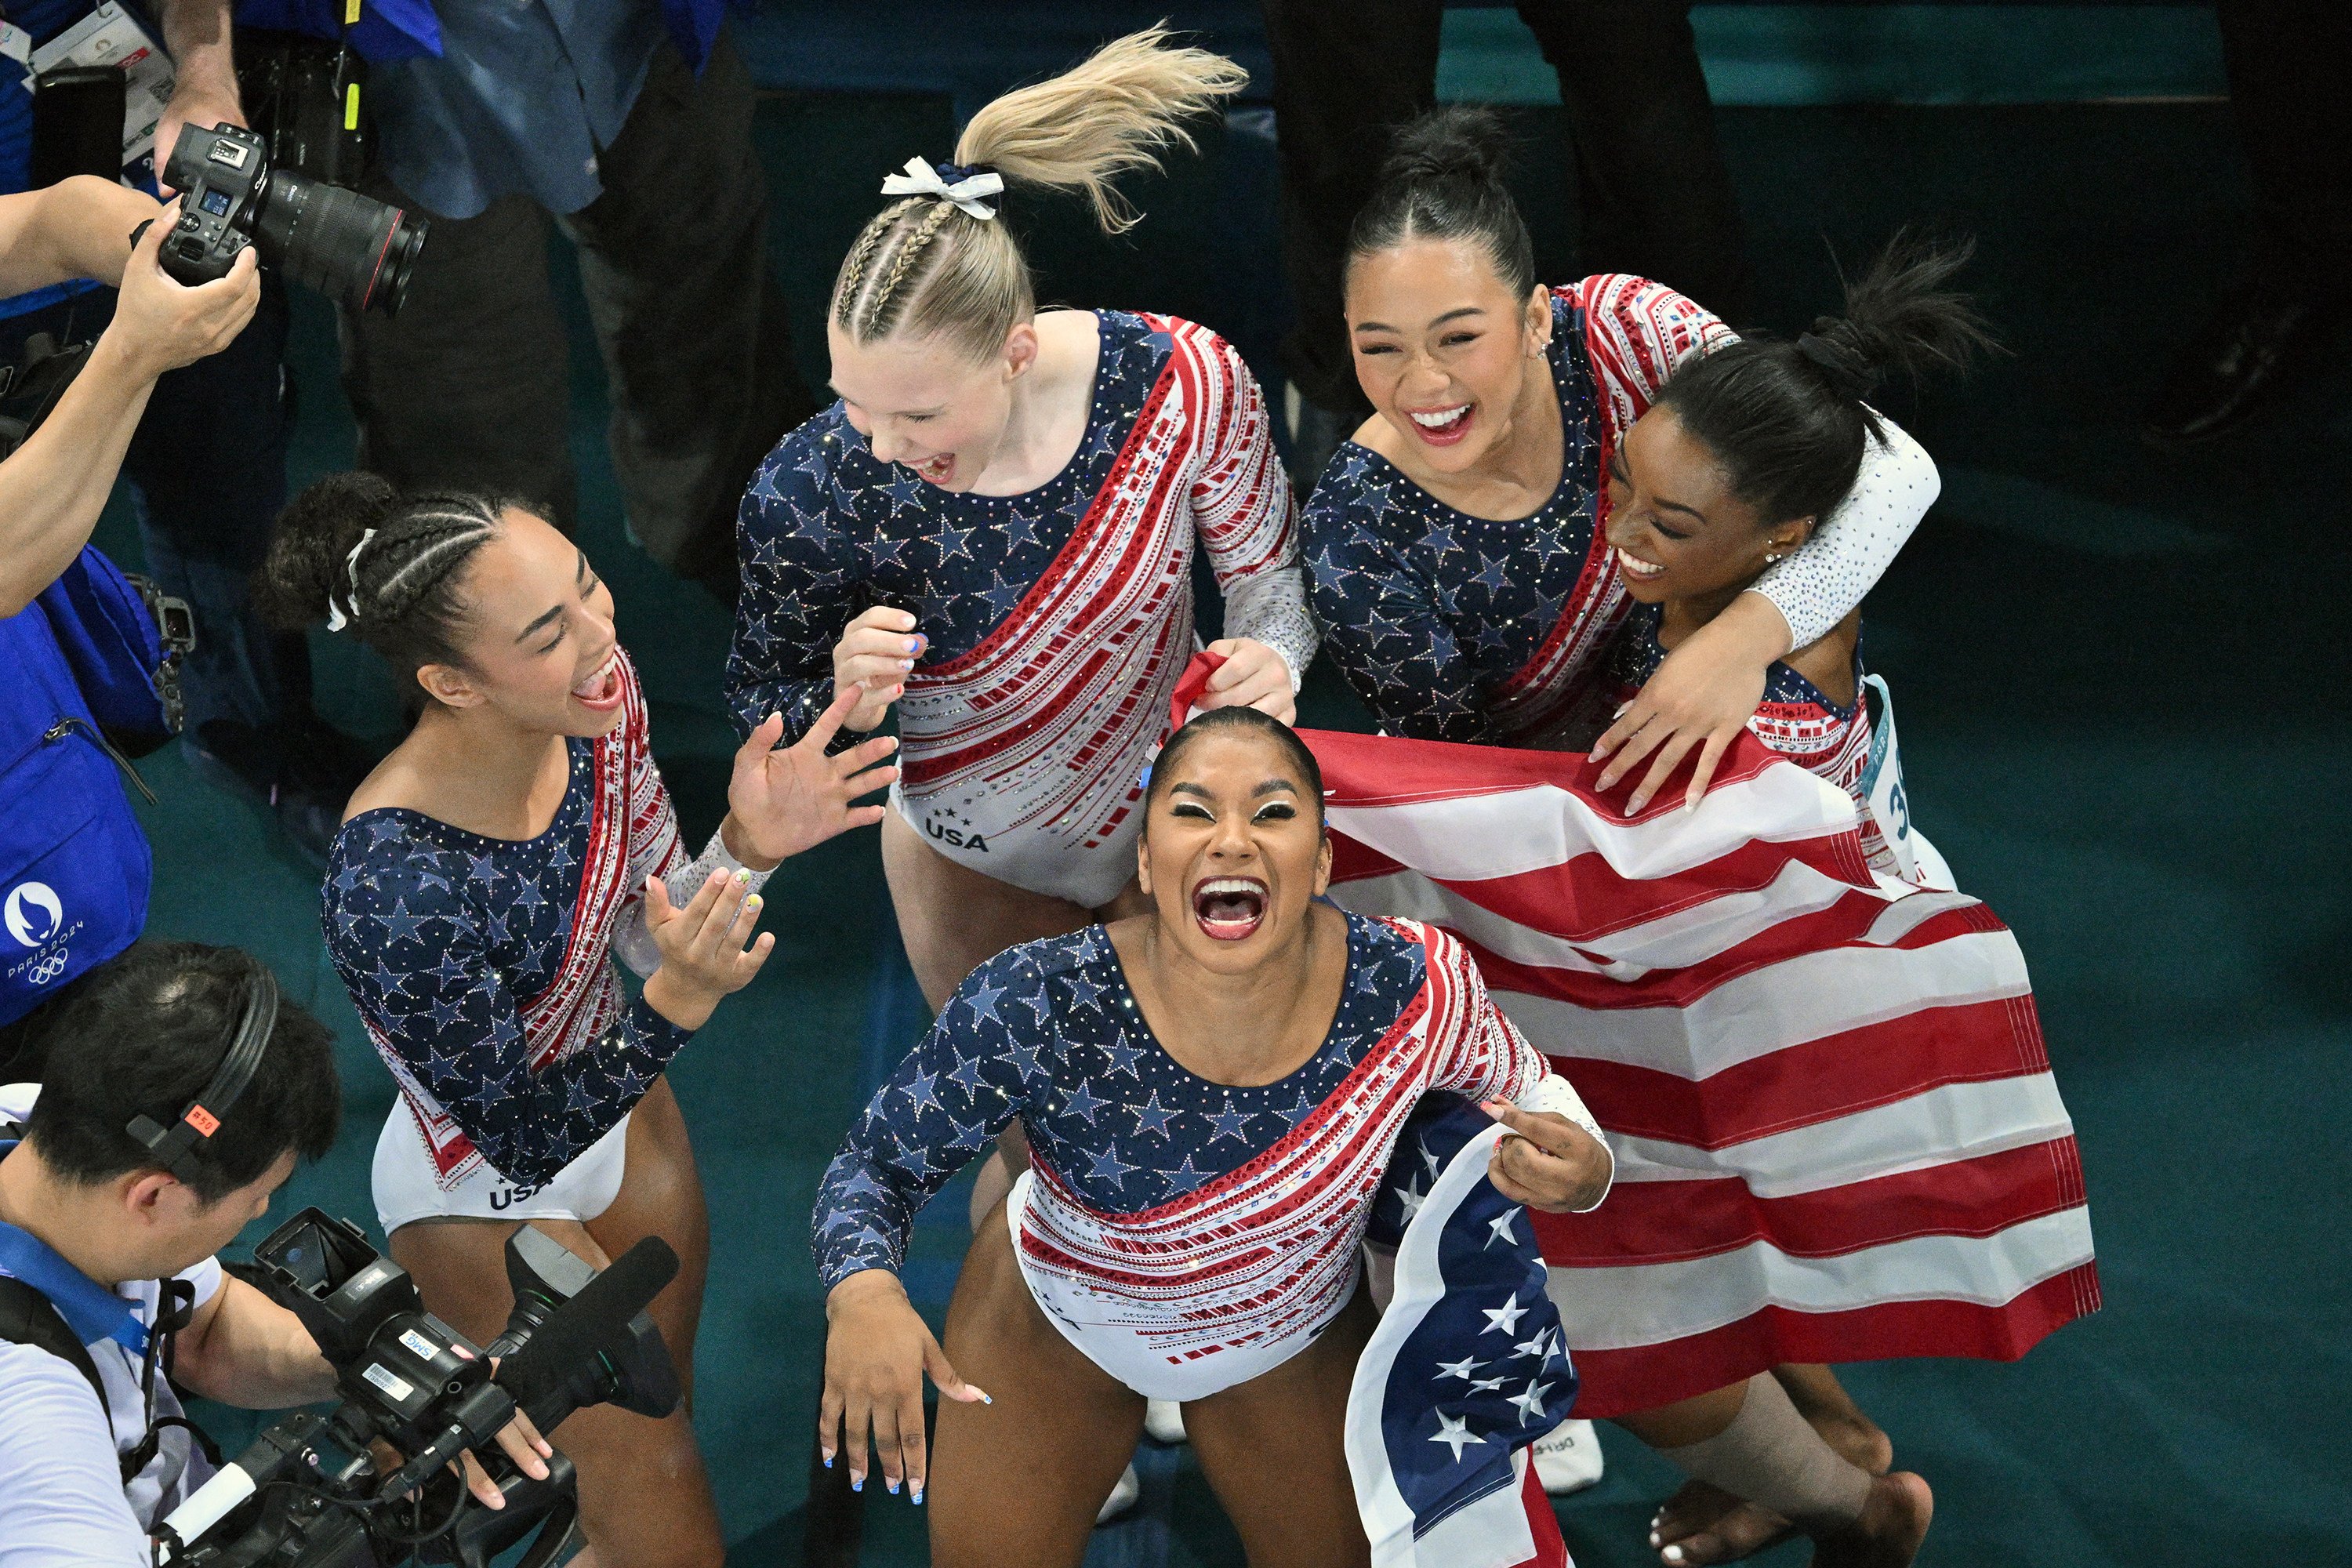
xmin=0 ymin=942 xmax=553 ymax=1568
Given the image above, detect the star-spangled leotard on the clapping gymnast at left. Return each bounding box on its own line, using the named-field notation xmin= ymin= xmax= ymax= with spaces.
xmin=322 ymin=654 xmax=743 ymax=1229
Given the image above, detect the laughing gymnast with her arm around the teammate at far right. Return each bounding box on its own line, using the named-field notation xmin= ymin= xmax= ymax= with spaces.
xmin=1301 ymin=108 xmax=1938 ymax=811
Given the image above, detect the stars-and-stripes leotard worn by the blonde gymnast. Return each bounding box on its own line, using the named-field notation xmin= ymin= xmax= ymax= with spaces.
xmin=727 ymin=310 xmax=1315 ymax=907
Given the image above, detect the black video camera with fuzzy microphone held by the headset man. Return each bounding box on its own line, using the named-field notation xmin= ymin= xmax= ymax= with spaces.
xmin=158 ymin=1208 xmax=677 ymax=1568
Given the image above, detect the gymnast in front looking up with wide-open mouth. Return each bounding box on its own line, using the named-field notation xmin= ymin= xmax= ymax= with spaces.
xmin=814 ymin=708 xmax=1613 ymax=1568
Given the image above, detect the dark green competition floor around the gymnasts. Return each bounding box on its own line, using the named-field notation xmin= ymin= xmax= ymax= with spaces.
xmin=103 ymin=99 xmax=2352 ymax=1568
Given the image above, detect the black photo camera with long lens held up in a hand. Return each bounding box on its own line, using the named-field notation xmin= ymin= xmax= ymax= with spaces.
xmin=162 ymin=125 xmax=428 ymax=315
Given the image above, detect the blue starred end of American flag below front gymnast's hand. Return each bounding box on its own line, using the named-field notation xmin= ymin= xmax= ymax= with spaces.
xmin=1348 ymin=1093 xmax=1576 ymax=1568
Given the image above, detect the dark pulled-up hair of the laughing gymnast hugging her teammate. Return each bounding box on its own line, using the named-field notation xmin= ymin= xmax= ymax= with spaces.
xmin=1348 ymin=106 xmax=1536 ymax=299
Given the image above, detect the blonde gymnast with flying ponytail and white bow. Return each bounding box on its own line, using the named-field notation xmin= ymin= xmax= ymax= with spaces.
xmin=727 ymin=28 xmax=1315 ymax=1008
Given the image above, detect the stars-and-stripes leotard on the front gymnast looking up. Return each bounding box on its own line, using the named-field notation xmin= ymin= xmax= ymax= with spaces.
xmin=816 ymin=914 xmax=1597 ymax=1399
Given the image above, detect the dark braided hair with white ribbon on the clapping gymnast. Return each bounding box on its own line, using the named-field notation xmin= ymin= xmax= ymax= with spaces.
xmin=254 ymin=473 xmax=529 ymax=677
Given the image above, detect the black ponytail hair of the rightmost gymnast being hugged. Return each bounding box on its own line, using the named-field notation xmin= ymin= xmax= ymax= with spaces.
xmin=1656 ymin=233 xmax=1999 ymax=529
